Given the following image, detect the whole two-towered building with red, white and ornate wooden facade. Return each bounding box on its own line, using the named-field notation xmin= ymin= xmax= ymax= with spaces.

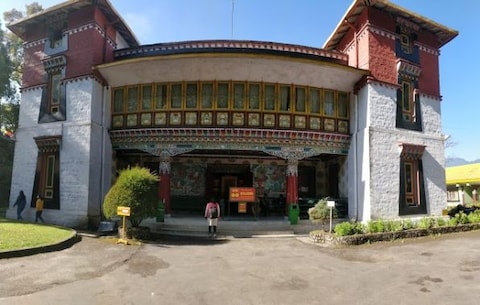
xmin=9 ymin=0 xmax=458 ymax=226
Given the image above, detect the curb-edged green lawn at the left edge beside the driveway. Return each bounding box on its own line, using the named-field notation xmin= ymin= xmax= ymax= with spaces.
xmin=0 ymin=218 xmax=76 ymax=252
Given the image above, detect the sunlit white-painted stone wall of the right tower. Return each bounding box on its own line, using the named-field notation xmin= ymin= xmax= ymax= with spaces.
xmin=368 ymin=84 xmax=446 ymax=218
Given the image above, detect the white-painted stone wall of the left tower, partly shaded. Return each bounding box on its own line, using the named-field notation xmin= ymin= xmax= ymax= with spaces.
xmin=7 ymin=78 xmax=111 ymax=227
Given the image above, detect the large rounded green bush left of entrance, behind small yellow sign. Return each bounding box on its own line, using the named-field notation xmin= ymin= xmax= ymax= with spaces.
xmin=103 ymin=166 xmax=159 ymax=227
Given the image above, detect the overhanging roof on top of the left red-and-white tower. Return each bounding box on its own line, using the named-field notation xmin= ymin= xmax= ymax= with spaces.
xmin=7 ymin=0 xmax=139 ymax=47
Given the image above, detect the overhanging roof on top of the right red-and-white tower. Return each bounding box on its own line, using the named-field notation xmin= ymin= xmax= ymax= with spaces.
xmin=323 ymin=0 xmax=458 ymax=50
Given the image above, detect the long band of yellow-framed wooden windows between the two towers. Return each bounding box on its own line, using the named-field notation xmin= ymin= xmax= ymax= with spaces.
xmin=111 ymin=80 xmax=350 ymax=134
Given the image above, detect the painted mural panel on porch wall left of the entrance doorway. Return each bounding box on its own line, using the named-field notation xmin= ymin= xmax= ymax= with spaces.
xmin=170 ymin=163 xmax=205 ymax=196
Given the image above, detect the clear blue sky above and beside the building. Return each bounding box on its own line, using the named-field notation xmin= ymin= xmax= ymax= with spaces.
xmin=0 ymin=0 xmax=480 ymax=161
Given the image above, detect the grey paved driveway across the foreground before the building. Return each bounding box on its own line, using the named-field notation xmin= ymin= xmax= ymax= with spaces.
xmin=0 ymin=231 xmax=480 ymax=305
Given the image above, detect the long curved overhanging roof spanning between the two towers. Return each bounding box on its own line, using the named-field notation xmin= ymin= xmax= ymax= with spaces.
xmin=95 ymin=40 xmax=368 ymax=91
